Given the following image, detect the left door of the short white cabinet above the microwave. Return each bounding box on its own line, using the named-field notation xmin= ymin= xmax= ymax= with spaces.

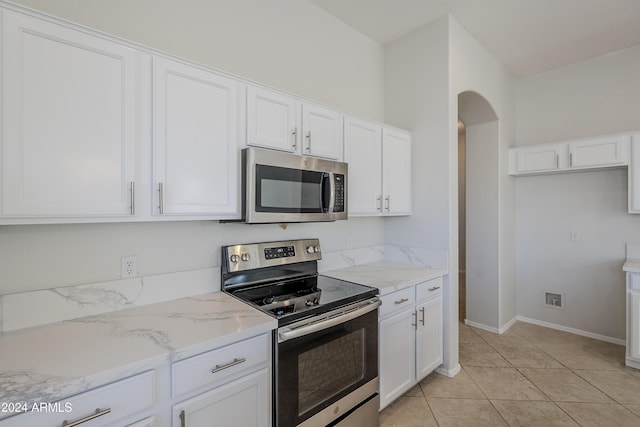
xmin=247 ymin=86 xmax=298 ymax=152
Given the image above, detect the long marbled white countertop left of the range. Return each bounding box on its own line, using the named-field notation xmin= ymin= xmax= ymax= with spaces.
xmin=0 ymin=292 xmax=277 ymax=412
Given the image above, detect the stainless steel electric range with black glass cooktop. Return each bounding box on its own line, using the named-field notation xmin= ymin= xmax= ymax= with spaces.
xmin=222 ymin=239 xmax=380 ymax=427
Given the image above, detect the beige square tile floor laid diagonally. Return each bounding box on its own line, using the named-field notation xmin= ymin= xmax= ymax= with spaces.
xmin=380 ymin=322 xmax=640 ymax=427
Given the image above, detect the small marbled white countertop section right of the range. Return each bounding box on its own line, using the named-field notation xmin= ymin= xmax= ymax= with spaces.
xmin=321 ymin=261 xmax=447 ymax=296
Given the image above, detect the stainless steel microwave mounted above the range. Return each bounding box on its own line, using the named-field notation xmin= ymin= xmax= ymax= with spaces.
xmin=242 ymin=148 xmax=347 ymax=224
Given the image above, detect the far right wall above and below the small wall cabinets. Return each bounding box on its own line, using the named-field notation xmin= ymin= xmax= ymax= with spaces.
xmin=516 ymin=47 xmax=640 ymax=340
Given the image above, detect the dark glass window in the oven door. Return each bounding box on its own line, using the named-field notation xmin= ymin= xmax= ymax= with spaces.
xmin=298 ymin=329 xmax=365 ymax=415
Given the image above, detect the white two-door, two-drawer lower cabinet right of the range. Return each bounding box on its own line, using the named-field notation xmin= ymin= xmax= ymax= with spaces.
xmin=379 ymin=278 xmax=443 ymax=409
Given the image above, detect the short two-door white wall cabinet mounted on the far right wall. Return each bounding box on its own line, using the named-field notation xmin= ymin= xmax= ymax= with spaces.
xmin=509 ymin=134 xmax=630 ymax=175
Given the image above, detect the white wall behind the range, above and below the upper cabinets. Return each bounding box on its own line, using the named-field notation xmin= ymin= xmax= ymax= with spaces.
xmin=0 ymin=0 xmax=384 ymax=295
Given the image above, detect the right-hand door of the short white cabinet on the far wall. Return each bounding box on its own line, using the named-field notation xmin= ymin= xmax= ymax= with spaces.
xmin=569 ymin=135 xmax=631 ymax=168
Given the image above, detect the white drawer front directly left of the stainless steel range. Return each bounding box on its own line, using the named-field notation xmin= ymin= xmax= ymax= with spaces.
xmin=171 ymin=334 xmax=269 ymax=396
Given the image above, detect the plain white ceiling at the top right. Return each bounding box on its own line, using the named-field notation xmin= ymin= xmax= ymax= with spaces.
xmin=311 ymin=0 xmax=640 ymax=76
